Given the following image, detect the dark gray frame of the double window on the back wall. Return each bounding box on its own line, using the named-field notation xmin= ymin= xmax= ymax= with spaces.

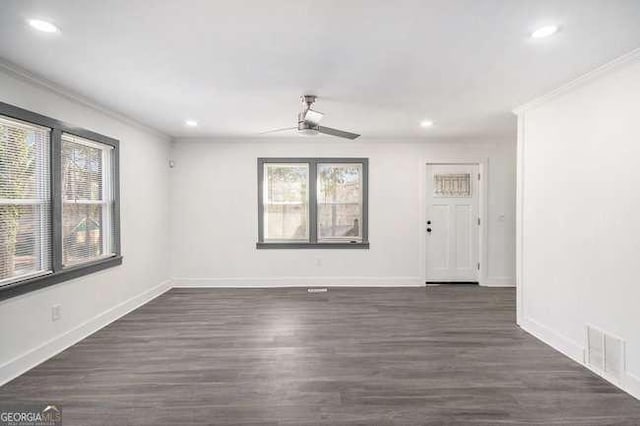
xmin=256 ymin=157 xmax=369 ymax=249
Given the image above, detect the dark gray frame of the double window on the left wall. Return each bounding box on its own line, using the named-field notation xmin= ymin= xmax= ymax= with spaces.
xmin=0 ymin=102 xmax=123 ymax=300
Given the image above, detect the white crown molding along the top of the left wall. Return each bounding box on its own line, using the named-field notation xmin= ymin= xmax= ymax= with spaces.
xmin=0 ymin=58 xmax=171 ymax=140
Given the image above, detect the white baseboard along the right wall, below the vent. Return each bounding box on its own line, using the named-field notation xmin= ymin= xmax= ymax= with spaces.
xmin=520 ymin=318 xmax=640 ymax=399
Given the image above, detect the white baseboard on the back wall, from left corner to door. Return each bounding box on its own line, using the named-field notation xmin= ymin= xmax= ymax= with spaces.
xmin=172 ymin=277 xmax=424 ymax=288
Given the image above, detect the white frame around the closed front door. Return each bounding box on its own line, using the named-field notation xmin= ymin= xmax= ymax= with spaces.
xmin=418 ymin=157 xmax=489 ymax=286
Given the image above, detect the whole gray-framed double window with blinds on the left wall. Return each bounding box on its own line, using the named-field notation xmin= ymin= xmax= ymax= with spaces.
xmin=0 ymin=102 xmax=122 ymax=299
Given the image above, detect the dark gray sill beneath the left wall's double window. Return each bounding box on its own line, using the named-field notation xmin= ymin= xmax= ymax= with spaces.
xmin=0 ymin=256 xmax=122 ymax=300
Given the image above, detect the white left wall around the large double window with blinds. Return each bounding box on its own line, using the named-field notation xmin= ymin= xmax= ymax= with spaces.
xmin=0 ymin=68 xmax=169 ymax=384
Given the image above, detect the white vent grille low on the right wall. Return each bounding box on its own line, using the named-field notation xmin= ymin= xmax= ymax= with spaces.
xmin=587 ymin=326 xmax=625 ymax=381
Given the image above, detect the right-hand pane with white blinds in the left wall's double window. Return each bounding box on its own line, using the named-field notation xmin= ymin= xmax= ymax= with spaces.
xmin=61 ymin=133 xmax=114 ymax=267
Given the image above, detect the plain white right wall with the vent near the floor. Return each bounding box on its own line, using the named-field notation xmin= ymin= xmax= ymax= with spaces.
xmin=518 ymin=52 xmax=640 ymax=398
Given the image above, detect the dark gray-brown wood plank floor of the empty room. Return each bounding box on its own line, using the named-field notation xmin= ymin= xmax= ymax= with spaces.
xmin=0 ymin=286 xmax=640 ymax=426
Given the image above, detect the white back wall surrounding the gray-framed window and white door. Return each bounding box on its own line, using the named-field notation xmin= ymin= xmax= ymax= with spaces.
xmin=171 ymin=138 xmax=515 ymax=285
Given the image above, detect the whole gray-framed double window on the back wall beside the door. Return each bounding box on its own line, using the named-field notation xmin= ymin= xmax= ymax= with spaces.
xmin=257 ymin=158 xmax=369 ymax=248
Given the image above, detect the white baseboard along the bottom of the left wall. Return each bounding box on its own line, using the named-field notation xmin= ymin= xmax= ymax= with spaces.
xmin=0 ymin=280 xmax=171 ymax=386
